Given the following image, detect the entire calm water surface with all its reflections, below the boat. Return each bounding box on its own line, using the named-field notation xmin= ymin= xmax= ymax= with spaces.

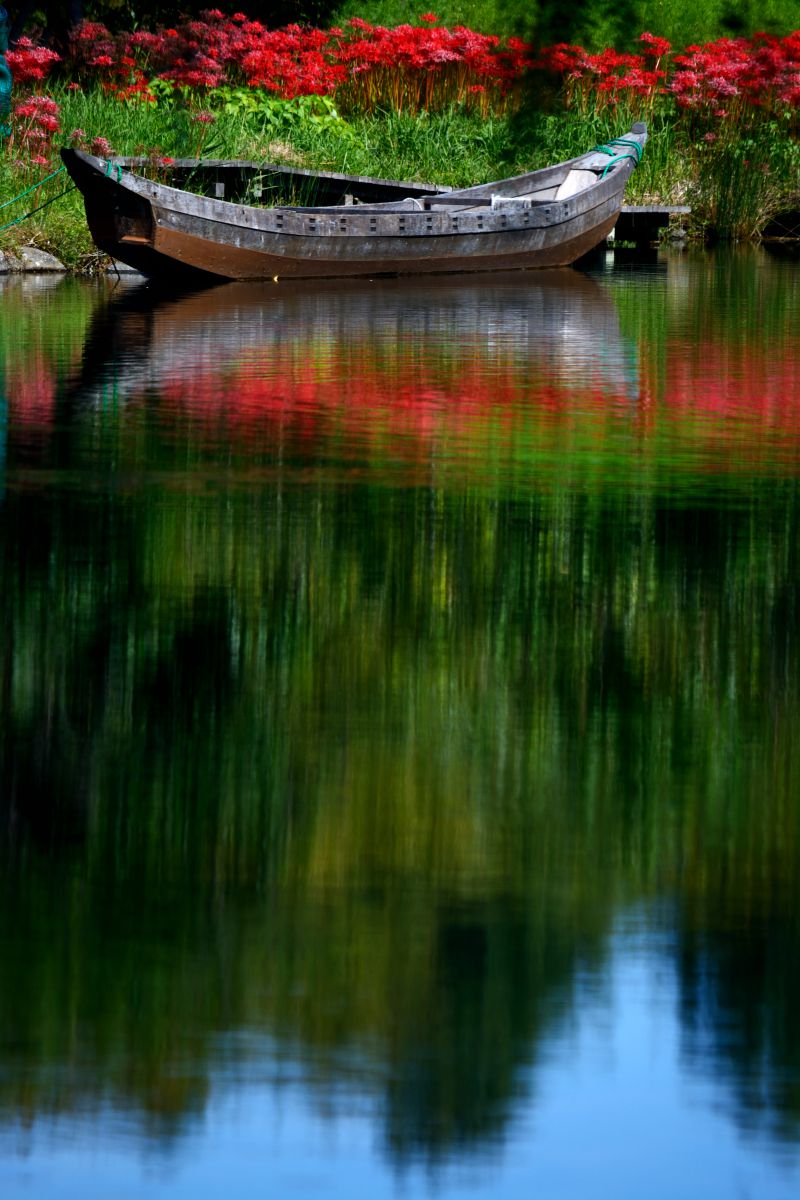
xmin=0 ymin=251 xmax=800 ymax=1200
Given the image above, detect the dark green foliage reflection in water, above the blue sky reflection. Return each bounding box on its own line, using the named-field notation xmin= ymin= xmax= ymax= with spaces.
xmin=0 ymin=255 xmax=800 ymax=1171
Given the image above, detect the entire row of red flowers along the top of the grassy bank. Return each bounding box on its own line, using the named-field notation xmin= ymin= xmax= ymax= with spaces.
xmin=8 ymin=10 xmax=800 ymax=129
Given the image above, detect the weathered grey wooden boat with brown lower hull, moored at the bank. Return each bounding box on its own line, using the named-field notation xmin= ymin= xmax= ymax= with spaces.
xmin=61 ymin=124 xmax=646 ymax=282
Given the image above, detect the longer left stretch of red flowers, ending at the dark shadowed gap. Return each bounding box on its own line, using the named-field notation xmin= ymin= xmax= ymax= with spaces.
xmin=10 ymin=10 xmax=531 ymax=109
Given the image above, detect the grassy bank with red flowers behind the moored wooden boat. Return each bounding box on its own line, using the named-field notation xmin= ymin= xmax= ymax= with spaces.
xmin=0 ymin=14 xmax=800 ymax=266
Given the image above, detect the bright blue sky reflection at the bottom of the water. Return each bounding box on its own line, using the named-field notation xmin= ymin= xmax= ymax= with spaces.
xmin=0 ymin=912 xmax=800 ymax=1200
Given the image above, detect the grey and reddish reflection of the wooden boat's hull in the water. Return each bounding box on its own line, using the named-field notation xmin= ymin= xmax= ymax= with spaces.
xmin=67 ymin=270 xmax=637 ymax=415
